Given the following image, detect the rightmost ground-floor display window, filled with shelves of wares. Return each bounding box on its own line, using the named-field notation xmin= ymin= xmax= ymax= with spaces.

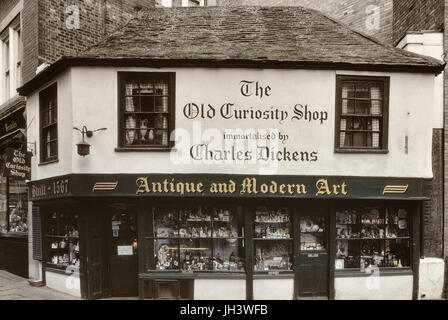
xmin=336 ymin=207 xmax=410 ymax=272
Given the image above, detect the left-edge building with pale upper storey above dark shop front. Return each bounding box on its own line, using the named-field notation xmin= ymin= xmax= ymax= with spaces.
xmin=0 ymin=1 xmax=30 ymax=277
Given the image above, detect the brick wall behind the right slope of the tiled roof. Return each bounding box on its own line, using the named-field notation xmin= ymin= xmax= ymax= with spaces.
xmin=217 ymin=0 xmax=393 ymax=43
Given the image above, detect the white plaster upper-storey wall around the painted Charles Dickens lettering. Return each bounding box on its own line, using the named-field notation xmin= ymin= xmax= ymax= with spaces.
xmin=27 ymin=67 xmax=434 ymax=180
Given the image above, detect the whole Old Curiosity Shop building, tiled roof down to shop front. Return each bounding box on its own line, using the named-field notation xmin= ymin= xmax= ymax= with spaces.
xmin=19 ymin=7 xmax=443 ymax=300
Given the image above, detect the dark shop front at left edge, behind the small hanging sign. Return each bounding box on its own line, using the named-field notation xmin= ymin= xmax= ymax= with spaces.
xmin=0 ymin=98 xmax=31 ymax=277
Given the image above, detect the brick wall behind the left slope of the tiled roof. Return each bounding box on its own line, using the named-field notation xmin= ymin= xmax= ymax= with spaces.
xmin=23 ymin=0 xmax=155 ymax=82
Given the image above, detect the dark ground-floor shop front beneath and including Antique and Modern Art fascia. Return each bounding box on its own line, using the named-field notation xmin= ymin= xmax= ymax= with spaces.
xmin=30 ymin=174 xmax=427 ymax=299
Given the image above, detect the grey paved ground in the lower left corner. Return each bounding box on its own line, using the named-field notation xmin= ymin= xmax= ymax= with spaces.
xmin=0 ymin=271 xmax=79 ymax=300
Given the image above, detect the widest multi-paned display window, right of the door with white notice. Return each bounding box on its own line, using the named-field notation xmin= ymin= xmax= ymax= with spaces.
xmin=147 ymin=206 xmax=244 ymax=272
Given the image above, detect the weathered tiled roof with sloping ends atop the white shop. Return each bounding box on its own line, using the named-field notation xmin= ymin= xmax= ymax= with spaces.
xmin=20 ymin=7 xmax=443 ymax=94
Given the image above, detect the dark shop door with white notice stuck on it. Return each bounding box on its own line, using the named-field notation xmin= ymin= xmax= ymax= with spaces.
xmin=109 ymin=210 xmax=138 ymax=297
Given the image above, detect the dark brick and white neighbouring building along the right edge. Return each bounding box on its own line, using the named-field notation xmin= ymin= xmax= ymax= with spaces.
xmin=393 ymin=0 xmax=448 ymax=299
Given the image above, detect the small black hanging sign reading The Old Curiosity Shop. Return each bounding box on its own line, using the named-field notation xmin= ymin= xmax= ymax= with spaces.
xmin=4 ymin=148 xmax=33 ymax=180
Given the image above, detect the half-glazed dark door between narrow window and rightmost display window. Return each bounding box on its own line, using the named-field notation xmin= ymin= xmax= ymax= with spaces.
xmin=296 ymin=213 xmax=329 ymax=298
